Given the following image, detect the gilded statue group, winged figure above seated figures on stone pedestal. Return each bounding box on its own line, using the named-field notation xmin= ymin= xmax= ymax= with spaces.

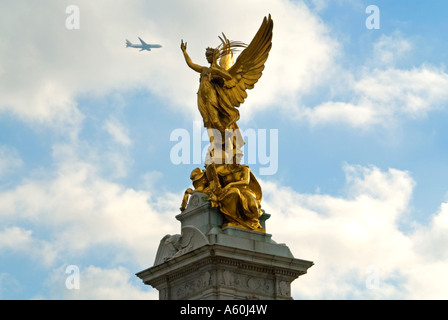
xmin=180 ymin=15 xmax=273 ymax=232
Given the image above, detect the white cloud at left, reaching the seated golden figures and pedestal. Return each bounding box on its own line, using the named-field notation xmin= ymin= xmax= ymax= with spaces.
xmin=0 ymin=149 xmax=180 ymax=265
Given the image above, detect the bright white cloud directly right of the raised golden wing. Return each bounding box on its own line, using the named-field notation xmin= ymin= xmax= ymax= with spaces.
xmin=242 ymin=1 xmax=340 ymax=115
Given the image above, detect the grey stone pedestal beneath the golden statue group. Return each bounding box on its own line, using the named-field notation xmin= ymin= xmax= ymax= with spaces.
xmin=137 ymin=193 xmax=313 ymax=300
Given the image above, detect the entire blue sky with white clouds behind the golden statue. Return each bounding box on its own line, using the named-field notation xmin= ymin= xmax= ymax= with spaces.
xmin=0 ymin=0 xmax=448 ymax=299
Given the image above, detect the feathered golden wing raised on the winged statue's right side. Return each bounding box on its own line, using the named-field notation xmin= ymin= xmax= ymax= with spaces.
xmin=217 ymin=15 xmax=274 ymax=108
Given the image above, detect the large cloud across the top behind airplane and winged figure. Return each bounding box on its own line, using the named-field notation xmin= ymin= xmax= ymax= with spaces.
xmin=0 ymin=0 xmax=337 ymax=127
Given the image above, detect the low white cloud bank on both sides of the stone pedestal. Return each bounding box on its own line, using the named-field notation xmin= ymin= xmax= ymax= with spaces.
xmin=0 ymin=139 xmax=448 ymax=299
